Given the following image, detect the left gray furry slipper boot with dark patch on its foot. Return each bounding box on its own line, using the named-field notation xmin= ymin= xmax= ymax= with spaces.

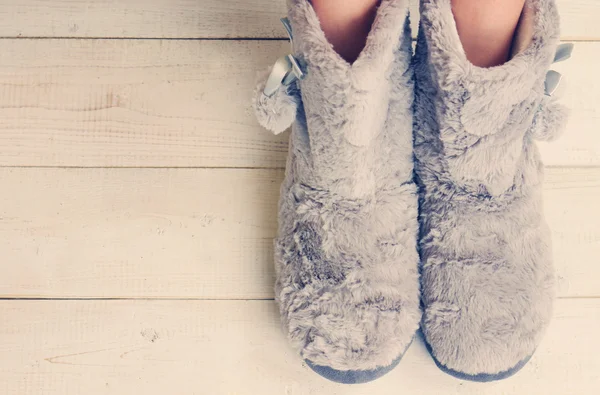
xmin=254 ymin=0 xmax=421 ymax=383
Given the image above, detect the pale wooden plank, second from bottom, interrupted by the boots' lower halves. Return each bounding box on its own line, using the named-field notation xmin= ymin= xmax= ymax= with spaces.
xmin=0 ymin=168 xmax=600 ymax=299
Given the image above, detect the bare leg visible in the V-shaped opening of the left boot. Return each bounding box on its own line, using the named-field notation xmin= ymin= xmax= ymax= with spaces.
xmin=311 ymin=0 xmax=380 ymax=63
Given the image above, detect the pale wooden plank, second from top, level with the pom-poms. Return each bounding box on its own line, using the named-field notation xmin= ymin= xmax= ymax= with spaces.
xmin=0 ymin=40 xmax=600 ymax=168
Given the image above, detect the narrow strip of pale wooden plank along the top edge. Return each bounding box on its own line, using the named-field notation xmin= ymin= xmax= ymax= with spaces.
xmin=0 ymin=0 xmax=600 ymax=40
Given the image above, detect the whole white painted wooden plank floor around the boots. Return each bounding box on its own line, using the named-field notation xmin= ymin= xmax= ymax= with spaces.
xmin=0 ymin=0 xmax=600 ymax=395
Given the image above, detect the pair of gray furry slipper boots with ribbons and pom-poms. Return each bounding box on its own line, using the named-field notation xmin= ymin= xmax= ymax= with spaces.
xmin=254 ymin=0 xmax=569 ymax=383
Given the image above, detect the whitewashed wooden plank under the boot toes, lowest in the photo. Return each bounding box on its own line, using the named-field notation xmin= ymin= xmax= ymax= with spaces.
xmin=0 ymin=299 xmax=600 ymax=395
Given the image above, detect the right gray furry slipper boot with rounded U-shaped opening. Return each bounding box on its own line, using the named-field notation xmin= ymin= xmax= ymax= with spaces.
xmin=414 ymin=0 xmax=572 ymax=381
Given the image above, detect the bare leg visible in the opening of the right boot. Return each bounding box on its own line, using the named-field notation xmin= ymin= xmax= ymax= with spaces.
xmin=452 ymin=0 xmax=525 ymax=67
